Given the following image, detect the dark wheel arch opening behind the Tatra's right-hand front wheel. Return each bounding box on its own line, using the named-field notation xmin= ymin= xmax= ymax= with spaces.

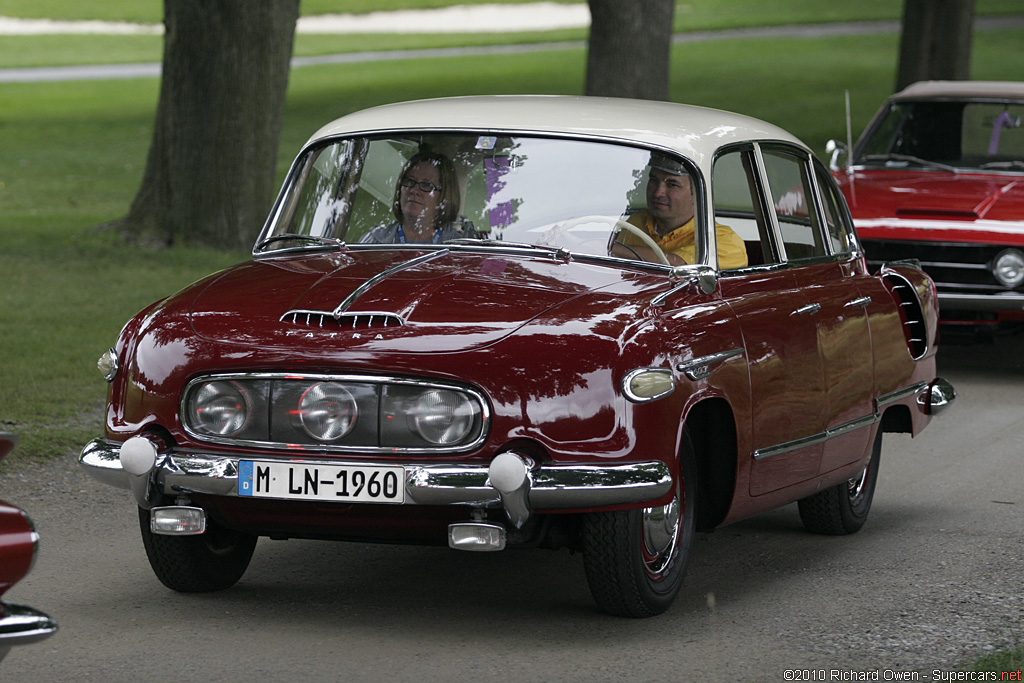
xmin=683 ymin=396 xmax=736 ymax=531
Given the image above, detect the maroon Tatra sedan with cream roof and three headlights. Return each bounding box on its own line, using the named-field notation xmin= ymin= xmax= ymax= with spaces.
xmin=80 ymin=96 xmax=955 ymax=616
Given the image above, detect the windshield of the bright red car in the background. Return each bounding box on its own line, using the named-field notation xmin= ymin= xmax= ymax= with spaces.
xmin=854 ymin=101 xmax=1024 ymax=172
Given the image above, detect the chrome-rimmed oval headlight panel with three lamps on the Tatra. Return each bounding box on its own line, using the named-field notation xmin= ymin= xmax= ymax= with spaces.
xmin=179 ymin=373 xmax=490 ymax=454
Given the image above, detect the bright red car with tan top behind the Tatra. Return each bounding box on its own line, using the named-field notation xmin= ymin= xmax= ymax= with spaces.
xmin=830 ymin=81 xmax=1024 ymax=333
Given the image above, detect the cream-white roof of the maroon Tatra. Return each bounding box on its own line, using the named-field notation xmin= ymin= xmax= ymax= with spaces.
xmin=309 ymin=95 xmax=808 ymax=166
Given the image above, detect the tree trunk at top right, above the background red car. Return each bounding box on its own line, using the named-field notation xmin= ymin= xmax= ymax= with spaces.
xmin=896 ymin=0 xmax=974 ymax=90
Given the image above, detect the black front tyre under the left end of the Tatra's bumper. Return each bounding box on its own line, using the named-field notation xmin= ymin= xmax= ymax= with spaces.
xmin=138 ymin=508 xmax=257 ymax=593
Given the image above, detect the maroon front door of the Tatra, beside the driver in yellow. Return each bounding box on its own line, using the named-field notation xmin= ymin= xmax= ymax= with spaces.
xmin=712 ymin=145 xmax=825 ymax=496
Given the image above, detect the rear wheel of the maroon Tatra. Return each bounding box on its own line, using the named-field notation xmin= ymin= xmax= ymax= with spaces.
xmin=798 ymin=429 xmax=882 ymax=536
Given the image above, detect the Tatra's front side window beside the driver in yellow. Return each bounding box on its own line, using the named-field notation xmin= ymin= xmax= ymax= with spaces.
xmin=712 ymin=150 xmax=779 ymax=265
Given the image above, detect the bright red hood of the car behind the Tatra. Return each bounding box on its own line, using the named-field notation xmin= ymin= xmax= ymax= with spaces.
xmin=837 ymin=170 xmax=1024 ymax=239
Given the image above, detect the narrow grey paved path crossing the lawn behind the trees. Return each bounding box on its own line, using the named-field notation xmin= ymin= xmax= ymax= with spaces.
xmin=0 ymin=15 xmax=1024 ymax=83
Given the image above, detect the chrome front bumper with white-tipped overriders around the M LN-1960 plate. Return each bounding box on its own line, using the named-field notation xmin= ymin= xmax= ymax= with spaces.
xmin=79 ymin=437 xmax=673 ymax=516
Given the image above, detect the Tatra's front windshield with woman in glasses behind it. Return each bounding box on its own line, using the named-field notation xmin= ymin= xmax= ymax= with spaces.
xmin=254 ymin=133 xmax=695 ymax=257
